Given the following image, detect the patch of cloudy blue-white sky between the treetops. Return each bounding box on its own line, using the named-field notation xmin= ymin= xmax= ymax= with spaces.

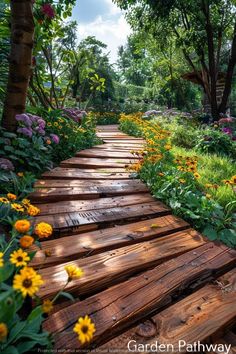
xmin=73 ymin=0 xmax=131 ymax=63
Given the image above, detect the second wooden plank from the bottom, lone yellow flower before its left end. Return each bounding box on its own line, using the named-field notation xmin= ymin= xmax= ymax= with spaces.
xmin=43 ymin=242 xmax=236 ymax=349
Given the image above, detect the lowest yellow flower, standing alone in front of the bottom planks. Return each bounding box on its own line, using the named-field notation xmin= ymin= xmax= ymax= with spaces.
xmin=73 ymin=315 xmax=96 ymax=344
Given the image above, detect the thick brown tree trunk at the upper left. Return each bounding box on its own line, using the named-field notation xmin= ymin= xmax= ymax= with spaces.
xmin=2 ymin=0 xmax=34 ymax=131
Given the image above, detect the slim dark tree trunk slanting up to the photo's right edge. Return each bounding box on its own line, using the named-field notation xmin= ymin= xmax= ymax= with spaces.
xmin=219 ymin=22 xmax=236 ymax=113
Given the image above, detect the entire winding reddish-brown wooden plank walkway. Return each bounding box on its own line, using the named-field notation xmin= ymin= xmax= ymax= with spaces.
xmin=31 ymin=125 xmax=236 ymax=353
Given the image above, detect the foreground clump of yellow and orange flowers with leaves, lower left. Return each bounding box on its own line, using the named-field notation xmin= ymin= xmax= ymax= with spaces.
xmin=0 ymin=199 xmax=95 ymax=354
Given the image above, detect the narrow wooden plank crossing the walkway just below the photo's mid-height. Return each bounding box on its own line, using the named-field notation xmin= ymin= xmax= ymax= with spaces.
xmin=29 ymin=183 xmax=148 ymax=203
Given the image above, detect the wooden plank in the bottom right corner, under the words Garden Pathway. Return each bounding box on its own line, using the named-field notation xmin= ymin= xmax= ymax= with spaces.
xmin=98 ymin=269 xmax=236 ymax=354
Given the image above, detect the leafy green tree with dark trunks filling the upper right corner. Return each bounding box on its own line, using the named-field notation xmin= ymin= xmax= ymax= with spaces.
xmin=115 ymin=0 xmax=236 ymax=120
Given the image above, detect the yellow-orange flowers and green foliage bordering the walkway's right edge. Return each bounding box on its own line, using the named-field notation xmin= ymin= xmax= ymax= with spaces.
xmin=120 ymin=115 xmax=236 ymax=247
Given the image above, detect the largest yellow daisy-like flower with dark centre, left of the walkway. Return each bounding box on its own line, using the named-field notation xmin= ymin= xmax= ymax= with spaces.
xmin=13 ymin=267 xmax=43 ymax=297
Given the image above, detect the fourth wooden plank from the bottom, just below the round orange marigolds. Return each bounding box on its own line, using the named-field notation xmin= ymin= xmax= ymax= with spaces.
xmin=31 ymin=215 xmax=191 ymax=267
